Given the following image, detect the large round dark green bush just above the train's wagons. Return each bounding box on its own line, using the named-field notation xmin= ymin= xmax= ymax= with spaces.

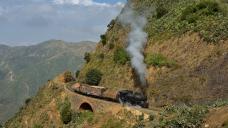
xmin=85 ymin=69 xmax=102 ymax=85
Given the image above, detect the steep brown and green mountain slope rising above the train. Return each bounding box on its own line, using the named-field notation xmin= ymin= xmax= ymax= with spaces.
xmin=79 ymin=0 xmax=228 ymax=107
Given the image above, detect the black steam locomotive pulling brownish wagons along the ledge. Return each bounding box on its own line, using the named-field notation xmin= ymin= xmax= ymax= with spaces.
xmin=71 ymin=83 xmax=149 ymax=108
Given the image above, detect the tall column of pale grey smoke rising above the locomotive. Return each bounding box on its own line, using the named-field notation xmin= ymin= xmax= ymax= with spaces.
xmin=118 ymin=5 xmax=147 ymax=86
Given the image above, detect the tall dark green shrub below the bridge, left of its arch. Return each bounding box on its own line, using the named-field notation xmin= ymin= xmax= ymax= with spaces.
xmin=59 ymin=99 xmax=72 ymax=124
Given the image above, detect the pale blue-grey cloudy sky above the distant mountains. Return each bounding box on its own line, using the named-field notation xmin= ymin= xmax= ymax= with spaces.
xmin=0 ymin=0 xmax=126 ymax=46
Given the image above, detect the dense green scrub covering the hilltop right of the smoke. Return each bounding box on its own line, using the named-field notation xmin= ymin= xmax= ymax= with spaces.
xmin=135 ymin=0 xmax=228 ymax=43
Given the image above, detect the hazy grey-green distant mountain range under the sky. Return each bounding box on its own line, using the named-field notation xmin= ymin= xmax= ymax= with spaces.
xmin=0 ymin=40 xmax=95 ymax=122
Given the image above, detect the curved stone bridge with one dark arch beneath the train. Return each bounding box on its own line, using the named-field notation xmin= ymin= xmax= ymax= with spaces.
xmin=65 ymin=85 xmax=159 ymax=119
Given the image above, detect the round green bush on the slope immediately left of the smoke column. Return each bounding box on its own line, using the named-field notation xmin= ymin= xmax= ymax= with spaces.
xmin=114 ymin=48 xmax=130 ymax=65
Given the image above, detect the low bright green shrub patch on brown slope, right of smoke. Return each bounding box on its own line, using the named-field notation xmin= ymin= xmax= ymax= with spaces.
xmin=145 ymin=54 xmax=176 ymax=67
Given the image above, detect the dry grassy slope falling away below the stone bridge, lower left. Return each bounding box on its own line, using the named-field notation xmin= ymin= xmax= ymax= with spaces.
xmin=5 ymin=75 xmax=133 ymax=128
